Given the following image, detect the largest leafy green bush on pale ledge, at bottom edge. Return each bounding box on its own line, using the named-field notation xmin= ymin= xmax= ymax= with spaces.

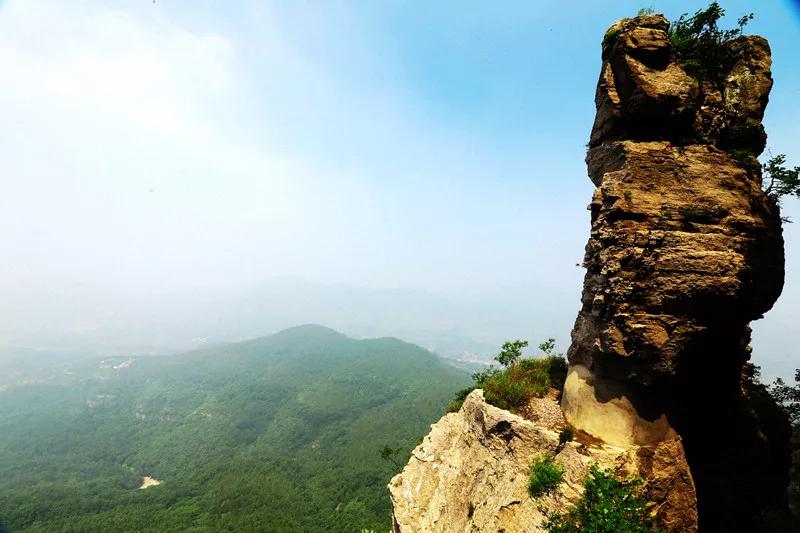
xmin=543 ymin=466 xmax=662 ymax=533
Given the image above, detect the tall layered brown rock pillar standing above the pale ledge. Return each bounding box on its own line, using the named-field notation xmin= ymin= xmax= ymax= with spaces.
xmin=562 ymin=16 xmax=785 ymax=531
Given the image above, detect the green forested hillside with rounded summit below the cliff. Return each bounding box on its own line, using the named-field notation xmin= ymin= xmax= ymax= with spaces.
xmin=0 ymin=326 xmax=469 ymax=531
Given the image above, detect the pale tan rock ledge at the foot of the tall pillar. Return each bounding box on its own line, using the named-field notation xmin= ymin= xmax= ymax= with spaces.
xmin=389 ymin=390 xmax=696 ymax=533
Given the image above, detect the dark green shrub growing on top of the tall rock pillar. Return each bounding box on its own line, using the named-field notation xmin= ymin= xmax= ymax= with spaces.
xmin=669 ymin=2 xmax=753 ymax=83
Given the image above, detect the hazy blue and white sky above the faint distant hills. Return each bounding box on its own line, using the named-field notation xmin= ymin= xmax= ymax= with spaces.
xmin=0 ymin=0 xmax=800 ymax=378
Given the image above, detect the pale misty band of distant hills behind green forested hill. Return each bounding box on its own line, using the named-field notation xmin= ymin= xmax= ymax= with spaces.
xmin=0 ymin=278 xmax=580 ymax=360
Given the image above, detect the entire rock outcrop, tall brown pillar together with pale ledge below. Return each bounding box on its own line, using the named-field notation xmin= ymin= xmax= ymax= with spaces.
xmin=390 ymin=16 xmax=788 ymax=533
